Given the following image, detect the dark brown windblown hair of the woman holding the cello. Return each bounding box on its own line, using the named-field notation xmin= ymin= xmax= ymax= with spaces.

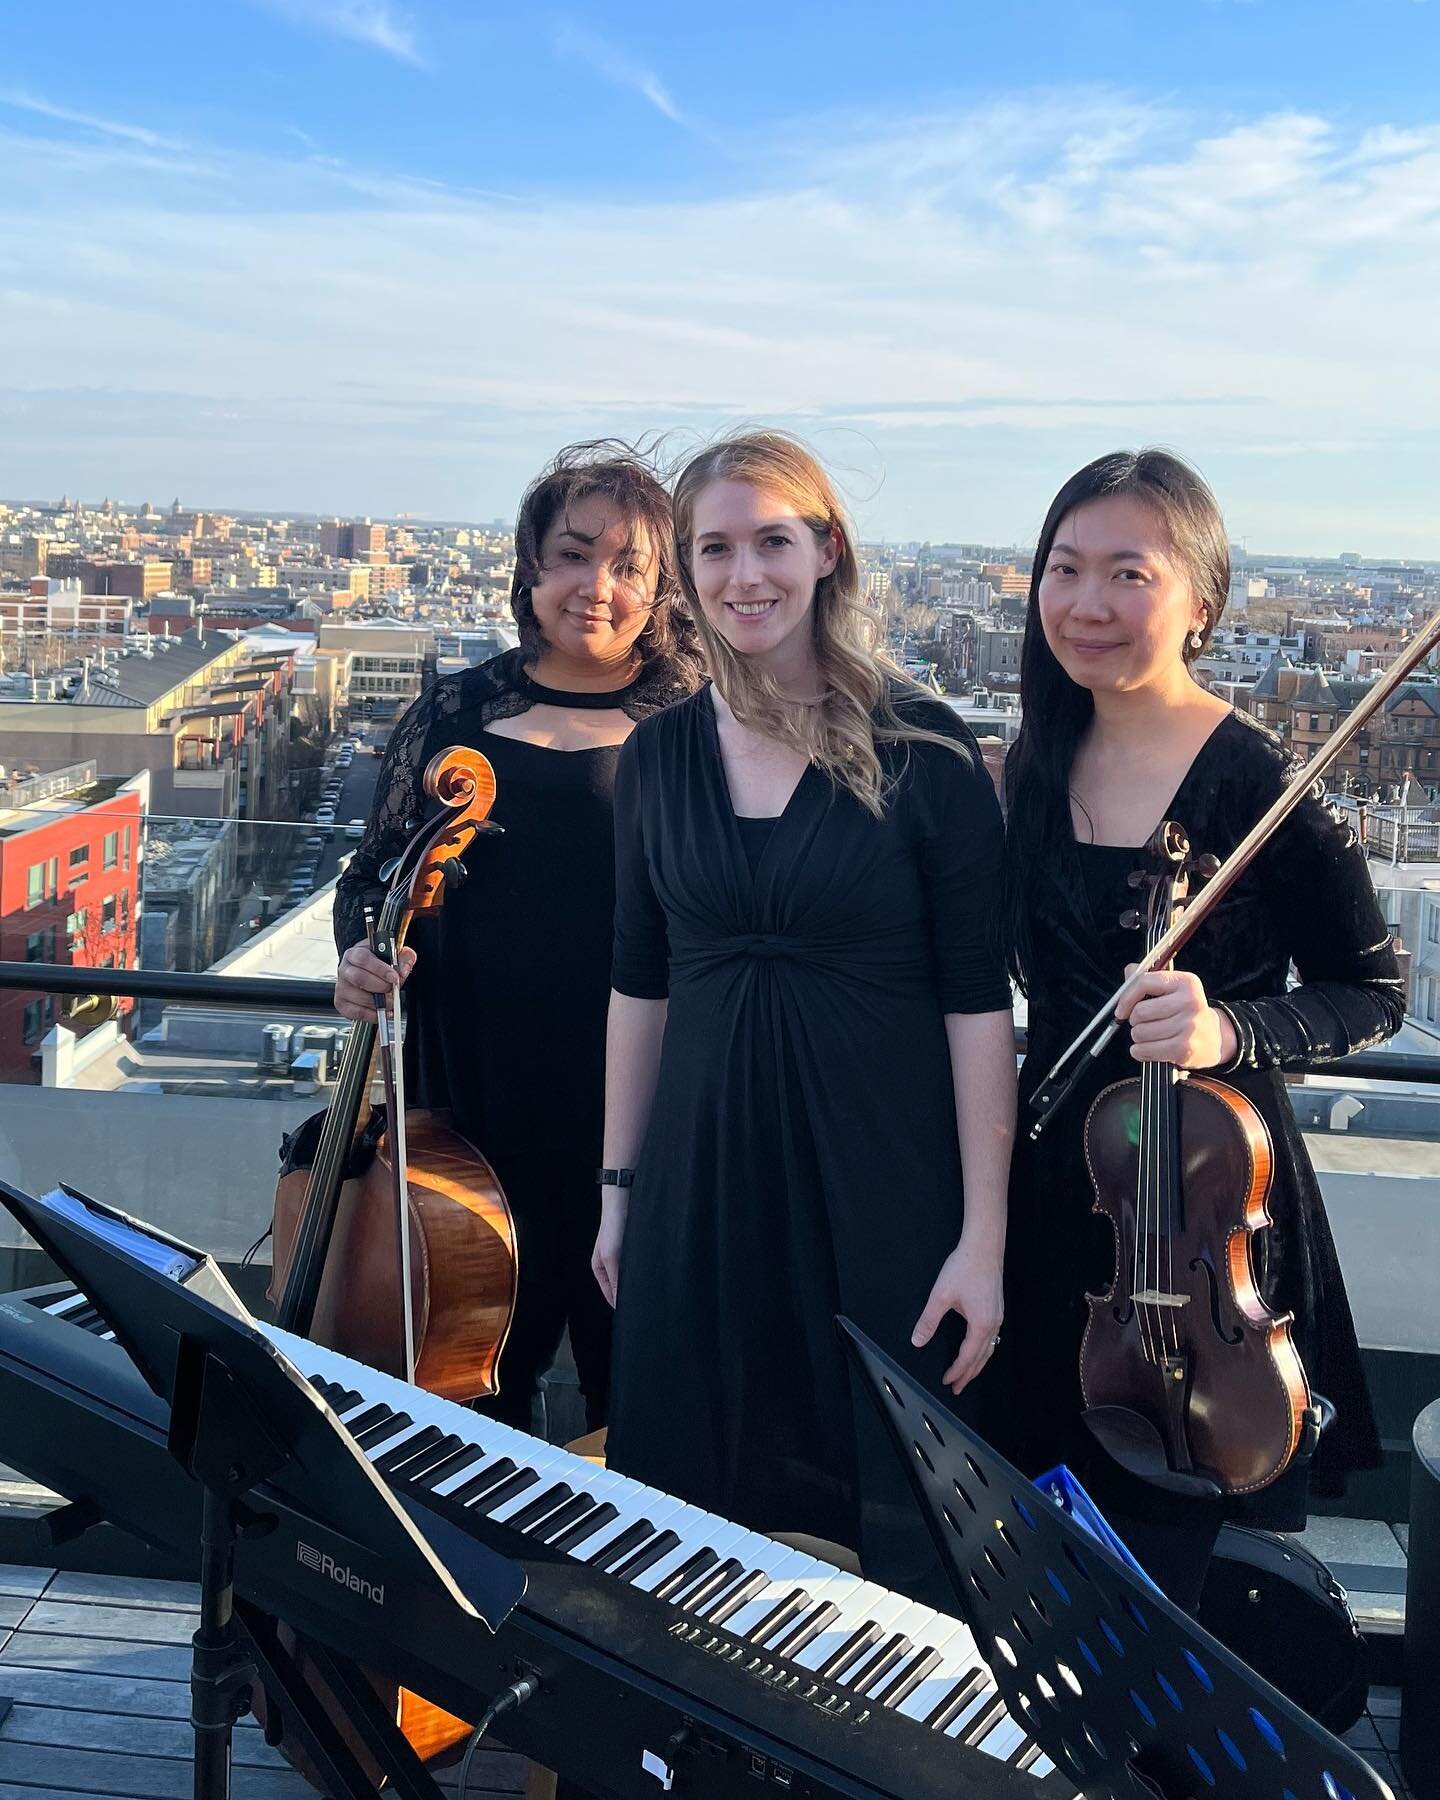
xmin=509 ymin=437 xmax=698 ymax=668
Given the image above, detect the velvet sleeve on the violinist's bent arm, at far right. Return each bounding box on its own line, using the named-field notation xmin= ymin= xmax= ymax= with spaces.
xmin=1222 ymin=763 xmax=1406 ymax=1069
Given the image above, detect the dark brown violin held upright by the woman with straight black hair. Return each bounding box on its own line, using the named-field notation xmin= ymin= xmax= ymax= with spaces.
xmin=1080 ymin=821 xmax=1319 ymax=1498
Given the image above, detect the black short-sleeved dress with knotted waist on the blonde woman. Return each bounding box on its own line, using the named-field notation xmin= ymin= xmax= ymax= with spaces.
xmin=608 ymin=691 xmax=1010 ymax=1593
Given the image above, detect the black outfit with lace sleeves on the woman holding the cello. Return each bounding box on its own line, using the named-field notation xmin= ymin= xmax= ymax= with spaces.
xmin=335 ymin=652 xmax=698 ymax=1429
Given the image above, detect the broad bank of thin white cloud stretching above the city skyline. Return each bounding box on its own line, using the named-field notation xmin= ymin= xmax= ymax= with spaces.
xmin=0 ymin=94 xmax=1440 ymax=553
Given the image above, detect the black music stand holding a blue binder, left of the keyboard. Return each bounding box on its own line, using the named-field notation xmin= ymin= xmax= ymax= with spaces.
xmin=0 ymin=1181 xmax=526 ymax=1800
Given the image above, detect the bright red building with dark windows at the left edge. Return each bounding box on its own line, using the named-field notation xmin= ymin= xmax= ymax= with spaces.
xmin=0 ymin=760 xmax=148 ymax=1082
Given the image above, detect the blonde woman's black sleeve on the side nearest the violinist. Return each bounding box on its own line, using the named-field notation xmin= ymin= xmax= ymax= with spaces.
xmin=911 ymin=731 xmax=1012 ymax=1013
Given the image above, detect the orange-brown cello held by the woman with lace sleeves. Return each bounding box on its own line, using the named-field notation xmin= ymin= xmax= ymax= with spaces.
xmin=261 ymin=747 xmax=518 ymax=1782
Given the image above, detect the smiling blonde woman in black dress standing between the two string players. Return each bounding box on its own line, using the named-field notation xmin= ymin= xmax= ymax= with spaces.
xmin=594 ymin=432 xmax=1015 ymax=1593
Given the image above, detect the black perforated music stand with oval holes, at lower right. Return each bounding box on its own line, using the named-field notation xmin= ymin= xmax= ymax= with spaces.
xmin=839 ymin=1319 xmax=1393 ymax=1800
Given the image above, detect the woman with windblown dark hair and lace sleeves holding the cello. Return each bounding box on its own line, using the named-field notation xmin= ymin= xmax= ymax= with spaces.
xmin=335 ymin=441 xmax=698 ymax=1429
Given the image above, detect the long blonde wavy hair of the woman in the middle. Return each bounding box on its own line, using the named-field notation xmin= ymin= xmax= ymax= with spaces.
xmin=675 ymin=432 xmax=970 ymax=817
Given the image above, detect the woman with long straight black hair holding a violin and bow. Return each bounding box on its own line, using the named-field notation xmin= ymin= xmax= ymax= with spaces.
xmin=1003 ymin=450 xmax=1404 ymax=1604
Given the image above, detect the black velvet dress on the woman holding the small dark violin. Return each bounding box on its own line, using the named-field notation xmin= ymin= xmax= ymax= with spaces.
xmin=1001 ymin=715 xmax=1404 ymax=1561
